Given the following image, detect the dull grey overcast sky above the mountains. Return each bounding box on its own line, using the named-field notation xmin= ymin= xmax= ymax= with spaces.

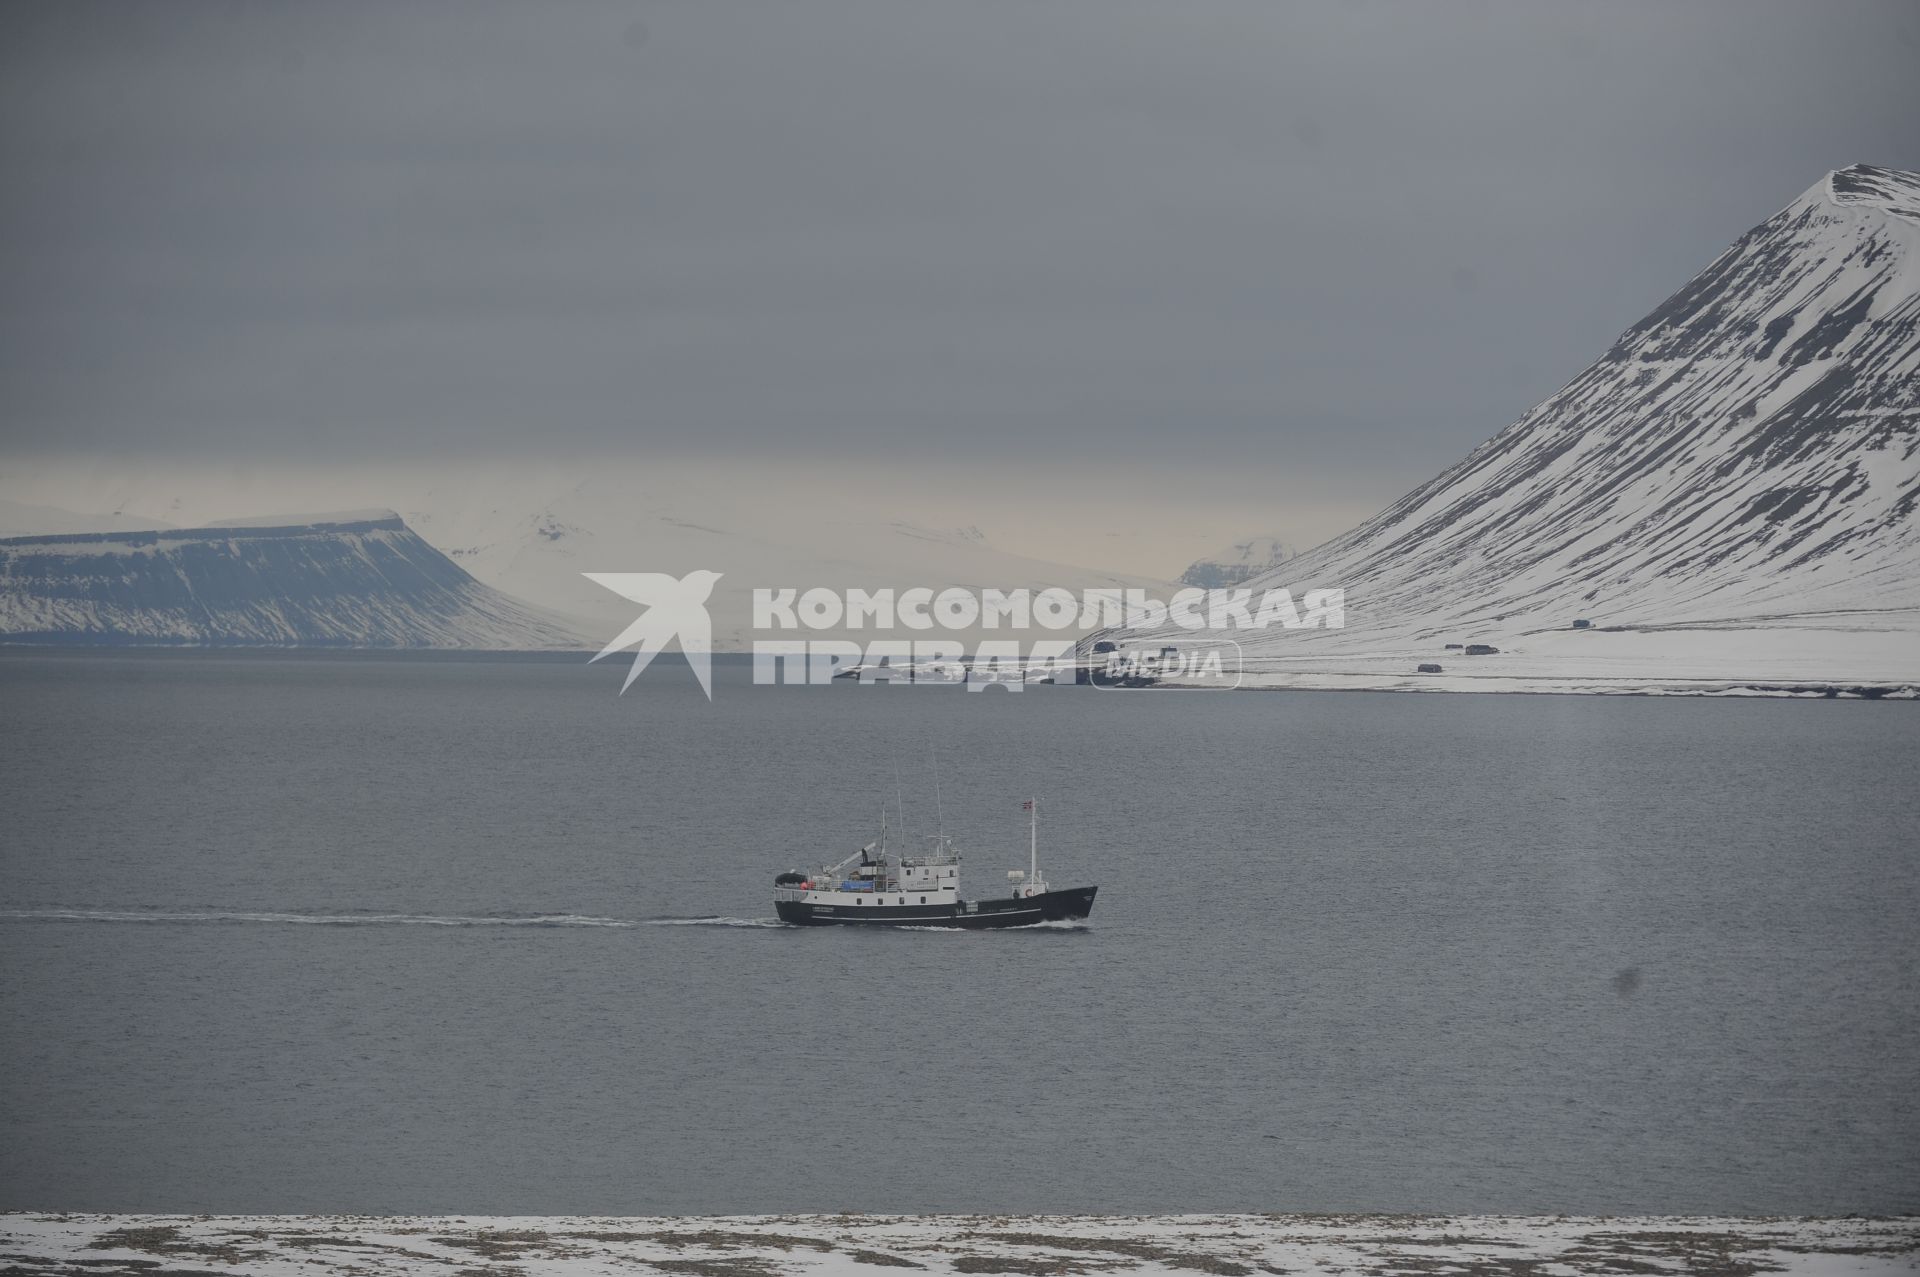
xmin=0 ymin=0 xmax=1920 ymax=564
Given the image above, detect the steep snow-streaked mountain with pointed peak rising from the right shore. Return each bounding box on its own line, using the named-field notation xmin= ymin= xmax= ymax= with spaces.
xmin=1128 ymin=165 xmax=1920 ymax=689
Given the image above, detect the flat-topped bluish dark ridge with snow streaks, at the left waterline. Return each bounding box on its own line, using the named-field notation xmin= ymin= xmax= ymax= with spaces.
xmin=0 ymin=513 xmax=582 ymax=649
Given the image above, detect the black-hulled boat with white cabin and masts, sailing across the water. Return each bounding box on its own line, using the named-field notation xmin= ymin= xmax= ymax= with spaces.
xmin=774 ymin=799 xmax=1098 ymax=929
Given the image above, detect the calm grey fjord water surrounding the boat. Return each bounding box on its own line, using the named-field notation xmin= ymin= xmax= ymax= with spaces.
xmin=0 ymin=653 xmax=1920 ymax=1214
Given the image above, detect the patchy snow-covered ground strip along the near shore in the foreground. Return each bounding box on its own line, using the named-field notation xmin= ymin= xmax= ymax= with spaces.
xmin=0 ymin=1214 xmax=1920 ymax=1277
